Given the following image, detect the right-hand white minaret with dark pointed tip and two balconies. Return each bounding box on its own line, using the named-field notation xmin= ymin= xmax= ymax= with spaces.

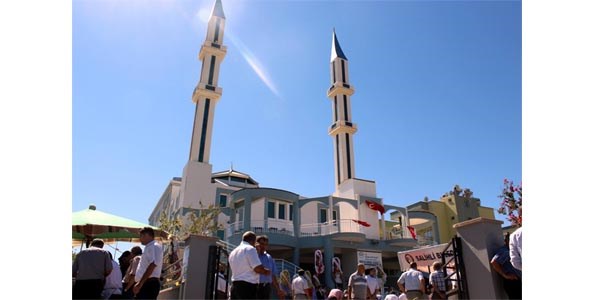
xmin=327 ymin=29 xmax=357 ymax=190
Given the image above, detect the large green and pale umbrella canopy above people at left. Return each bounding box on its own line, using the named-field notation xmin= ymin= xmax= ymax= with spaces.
xmin=71 ymin=204 xmax=168 ymax=243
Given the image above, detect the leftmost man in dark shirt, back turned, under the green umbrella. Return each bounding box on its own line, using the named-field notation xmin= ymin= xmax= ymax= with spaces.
xmin=72 ymin=239 xmax=113 ymax=299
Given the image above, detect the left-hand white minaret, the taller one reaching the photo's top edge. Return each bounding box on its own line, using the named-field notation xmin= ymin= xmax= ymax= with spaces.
xmin=189 ymin=0 xmax=227 ymax=163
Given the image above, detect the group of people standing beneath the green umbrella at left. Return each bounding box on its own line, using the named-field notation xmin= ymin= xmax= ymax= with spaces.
xmin=72 ymin=227 xmax=163 ymax=299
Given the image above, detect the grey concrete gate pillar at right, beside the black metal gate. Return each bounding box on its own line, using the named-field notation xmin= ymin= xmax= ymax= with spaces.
xmin=454 ymin=218 xmax=507 ymax=299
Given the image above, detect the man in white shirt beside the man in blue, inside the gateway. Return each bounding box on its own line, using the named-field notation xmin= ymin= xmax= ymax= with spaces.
xmin=229 ymin=231 xmax=271 ymax=299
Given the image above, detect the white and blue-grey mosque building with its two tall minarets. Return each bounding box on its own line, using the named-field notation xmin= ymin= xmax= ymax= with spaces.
xmin=149 ymin=0 xmax=493 ymax=287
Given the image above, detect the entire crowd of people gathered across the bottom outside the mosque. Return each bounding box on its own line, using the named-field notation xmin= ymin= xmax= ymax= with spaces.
xmin=72 ymin=227 xmax=522 ymax=300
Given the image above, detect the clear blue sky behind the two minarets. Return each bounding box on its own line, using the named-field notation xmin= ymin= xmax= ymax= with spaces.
xmin=72 ymin=0 xmax=527 ymax=222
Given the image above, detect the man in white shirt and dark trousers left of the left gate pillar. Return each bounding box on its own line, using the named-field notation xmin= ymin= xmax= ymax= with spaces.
xmin=133 ymin=227 xmax=163 ymax=299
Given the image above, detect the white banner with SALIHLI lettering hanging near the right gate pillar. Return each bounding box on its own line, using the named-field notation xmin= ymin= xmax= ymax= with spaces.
xmin=398 ymin=244 xmax=454 ymax=273
